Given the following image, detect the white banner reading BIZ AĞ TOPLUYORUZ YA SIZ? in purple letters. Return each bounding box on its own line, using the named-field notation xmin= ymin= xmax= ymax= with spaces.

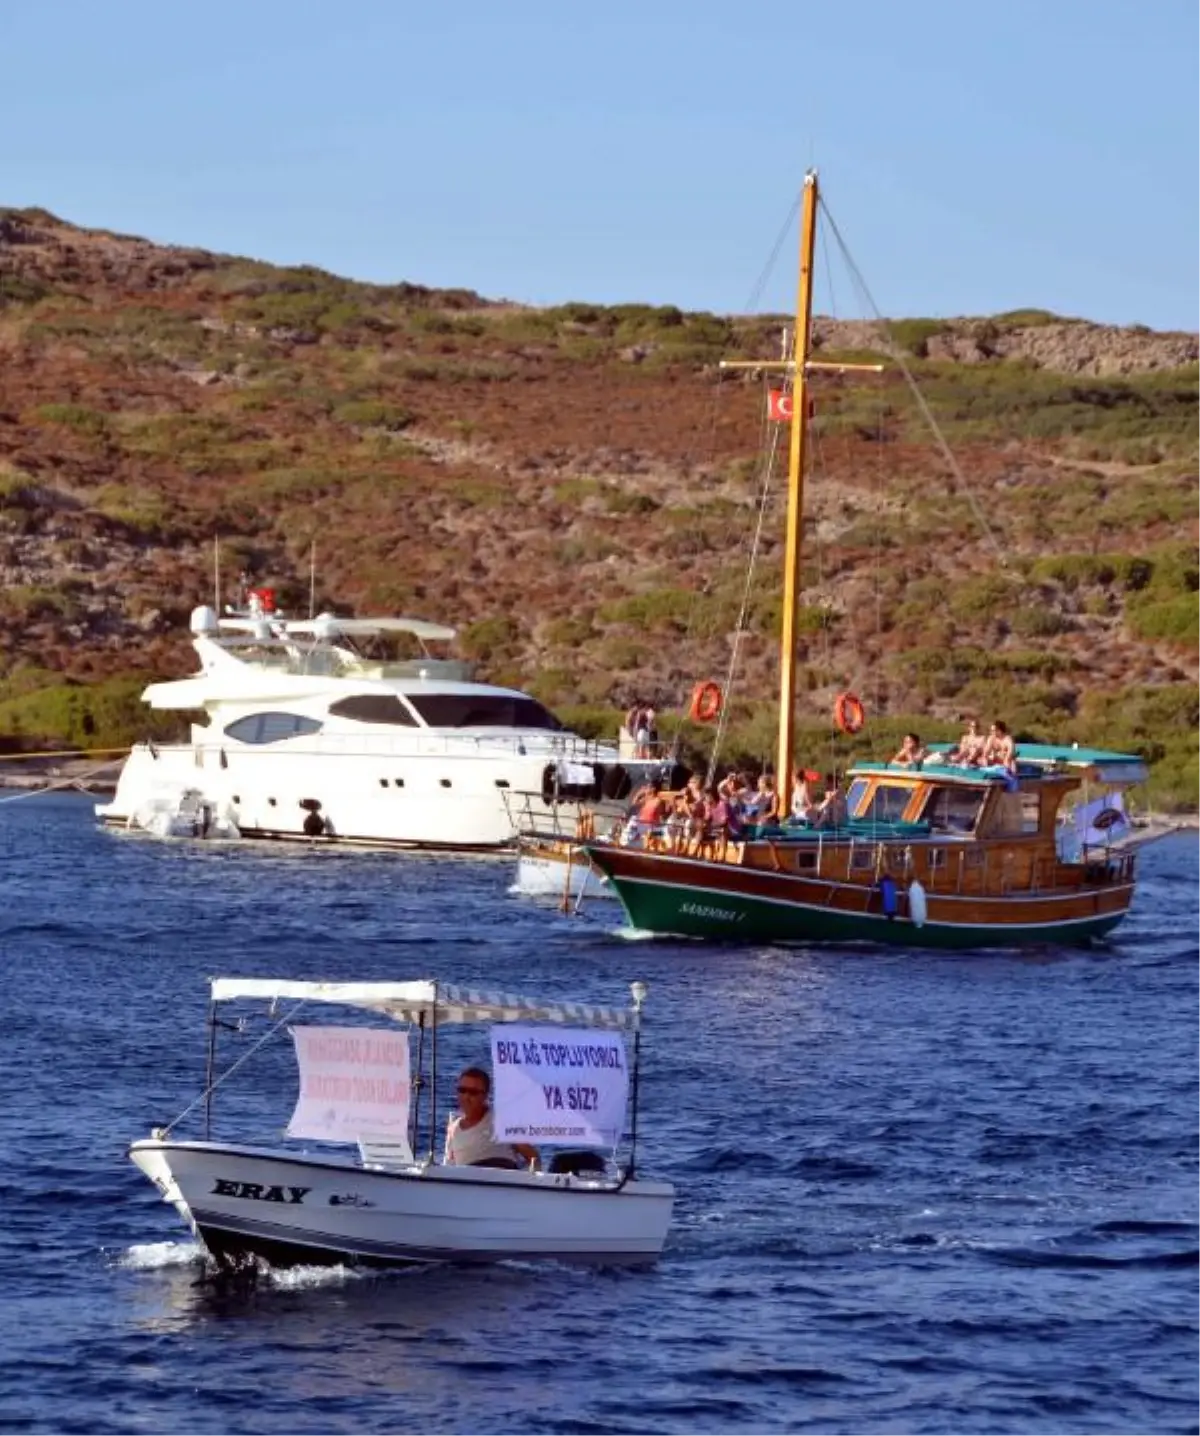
xmin=491 ymin=1022 xmax=629 ymax=1147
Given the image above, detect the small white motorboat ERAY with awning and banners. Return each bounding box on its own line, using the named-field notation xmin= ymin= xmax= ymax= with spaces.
xmin=129 ymin=978 xmax=675 ymax=1271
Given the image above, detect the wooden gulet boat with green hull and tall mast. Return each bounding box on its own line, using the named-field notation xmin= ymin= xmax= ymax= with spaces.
xmin=586 ymin=172 xmax=1147 ymax=949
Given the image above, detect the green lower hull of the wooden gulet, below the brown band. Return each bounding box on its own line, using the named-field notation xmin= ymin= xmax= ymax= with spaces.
xmin=610 ymin=876 xmax=1125 ymax=952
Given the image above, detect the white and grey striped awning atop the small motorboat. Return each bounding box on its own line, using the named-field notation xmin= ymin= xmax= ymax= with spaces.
xmin=212 ymin=978 xmax=636 ymax=1028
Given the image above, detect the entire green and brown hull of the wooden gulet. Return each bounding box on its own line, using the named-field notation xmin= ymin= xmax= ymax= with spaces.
xmin=589 ymin=846 xmax=1134 ymax=951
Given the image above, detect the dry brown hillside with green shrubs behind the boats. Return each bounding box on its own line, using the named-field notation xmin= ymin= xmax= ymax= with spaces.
xmin=0 ymin=210 xmax=1200 ymax=800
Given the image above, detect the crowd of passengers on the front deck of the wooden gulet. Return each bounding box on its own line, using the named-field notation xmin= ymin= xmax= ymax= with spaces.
xmin=619 ymin=768 xmax=847 ymax=854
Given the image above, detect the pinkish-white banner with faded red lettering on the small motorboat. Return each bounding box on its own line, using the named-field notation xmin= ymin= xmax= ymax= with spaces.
xmin=287 ymin=1027 xmax=411 ymax=1142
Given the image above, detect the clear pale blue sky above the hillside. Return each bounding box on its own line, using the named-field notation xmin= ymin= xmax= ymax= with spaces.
xmin=0 ymin=0 xmax=1200 ymax=330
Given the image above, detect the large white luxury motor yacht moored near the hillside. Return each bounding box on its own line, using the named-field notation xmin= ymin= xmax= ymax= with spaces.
xmin=96 ymin=602 xmax=656 ymax=849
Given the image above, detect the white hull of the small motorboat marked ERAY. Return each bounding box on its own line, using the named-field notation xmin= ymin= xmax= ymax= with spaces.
xmin=129 ymin=1139 xmax=675 ymax=1267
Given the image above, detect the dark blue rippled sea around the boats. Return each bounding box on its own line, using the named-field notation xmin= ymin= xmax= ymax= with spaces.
xmin=0 ymin=796 xmax=1200 ymax=1436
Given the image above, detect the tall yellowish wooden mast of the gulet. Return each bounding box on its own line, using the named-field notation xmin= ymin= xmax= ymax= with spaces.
xmin=775 ymin=169 xmax=818 ymax=803
